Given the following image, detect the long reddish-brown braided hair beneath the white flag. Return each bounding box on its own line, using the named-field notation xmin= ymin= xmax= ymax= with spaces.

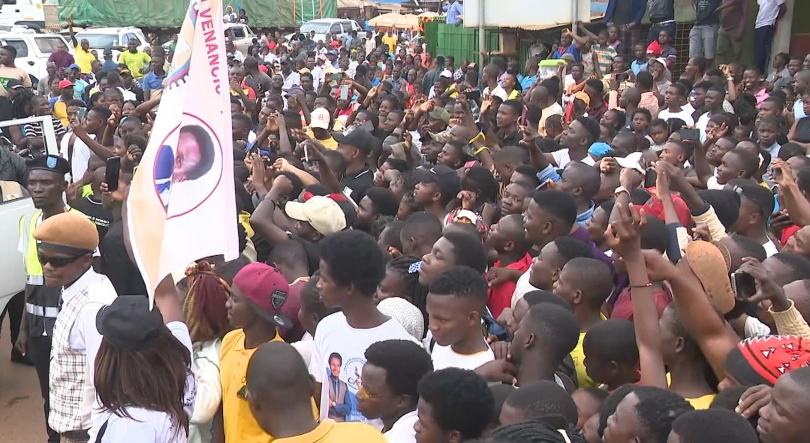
xmin=183 ymin=260 xmax=231 ymax=343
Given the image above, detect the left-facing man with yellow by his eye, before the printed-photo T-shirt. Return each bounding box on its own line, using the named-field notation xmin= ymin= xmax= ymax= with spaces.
xmin=357 ymin=340 xmax=433 ymax=443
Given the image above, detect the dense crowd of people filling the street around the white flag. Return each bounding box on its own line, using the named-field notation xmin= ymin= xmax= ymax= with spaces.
xmin=0 ymin=0 xmax=810 ymax=443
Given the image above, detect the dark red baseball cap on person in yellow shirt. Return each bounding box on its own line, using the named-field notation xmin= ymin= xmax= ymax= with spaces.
xmin=233 ymin=262 xmax=292 ymax=328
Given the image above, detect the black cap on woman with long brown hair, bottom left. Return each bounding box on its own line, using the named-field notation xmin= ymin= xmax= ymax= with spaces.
xmin=96 ymin=295 xmax=165 ymax=352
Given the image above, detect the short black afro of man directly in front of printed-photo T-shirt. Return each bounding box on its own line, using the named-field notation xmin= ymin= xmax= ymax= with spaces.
xmin=365 ymin=340 xmax=433 ymax=407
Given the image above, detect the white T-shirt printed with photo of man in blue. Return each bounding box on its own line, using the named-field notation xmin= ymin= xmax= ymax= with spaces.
xmin=309 ymin=312 xmax=419 ymax=429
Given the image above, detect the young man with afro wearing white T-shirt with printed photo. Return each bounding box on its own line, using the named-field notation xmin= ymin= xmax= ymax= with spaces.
xmin=306 ymin=231 xmax=416 ymax=429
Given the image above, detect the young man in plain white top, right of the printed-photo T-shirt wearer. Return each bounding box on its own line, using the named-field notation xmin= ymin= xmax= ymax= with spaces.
xmin=427 ymin=266 xmax=495 ymax=371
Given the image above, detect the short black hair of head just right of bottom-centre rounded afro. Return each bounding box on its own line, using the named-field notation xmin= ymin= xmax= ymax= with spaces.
xmin=506 ymin=380 xmax=578 ymax=429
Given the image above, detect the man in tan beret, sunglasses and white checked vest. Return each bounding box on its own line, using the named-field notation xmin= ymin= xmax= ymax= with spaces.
xmin=34 ymin=212 xmax=117 ymax=442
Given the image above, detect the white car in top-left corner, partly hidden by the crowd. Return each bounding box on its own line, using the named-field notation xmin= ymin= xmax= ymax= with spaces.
xmin=0 ymin=30 xmax=73 ymax=80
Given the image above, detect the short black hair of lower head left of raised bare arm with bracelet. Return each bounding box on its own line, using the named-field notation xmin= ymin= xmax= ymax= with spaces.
xmin=582 ymin=318 xmax=638 ymax=365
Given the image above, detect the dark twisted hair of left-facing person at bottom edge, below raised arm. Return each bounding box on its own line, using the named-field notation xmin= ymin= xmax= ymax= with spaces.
xmin=633 ymin=386 xmax=696 ymax=443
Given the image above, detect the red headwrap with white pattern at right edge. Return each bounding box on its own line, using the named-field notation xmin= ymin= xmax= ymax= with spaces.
xmin=725 ymin=335 xmax=810 ymax=386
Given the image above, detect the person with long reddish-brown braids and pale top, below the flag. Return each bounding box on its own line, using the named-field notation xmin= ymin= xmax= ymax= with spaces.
xmin=182 ymin=260 xmax=231 ymax=443
